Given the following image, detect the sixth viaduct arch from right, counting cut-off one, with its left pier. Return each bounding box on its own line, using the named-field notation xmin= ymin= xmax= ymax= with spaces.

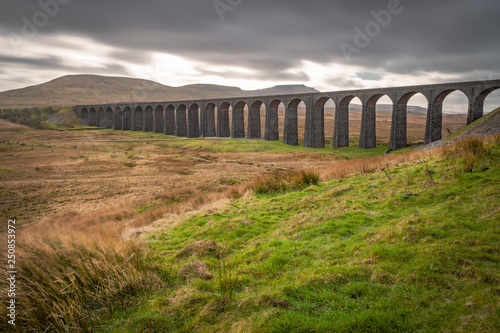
xmin=312 ymin=96 xmax=336 ymax=148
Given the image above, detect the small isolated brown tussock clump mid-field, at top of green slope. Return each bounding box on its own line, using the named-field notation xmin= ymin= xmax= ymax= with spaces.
xmin=249 ymin=170 xmax=319 ymax=194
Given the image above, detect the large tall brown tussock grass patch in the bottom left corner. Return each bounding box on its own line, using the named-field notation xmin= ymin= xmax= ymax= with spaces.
xmin=2 ymin=239 xmax=161 ymax=332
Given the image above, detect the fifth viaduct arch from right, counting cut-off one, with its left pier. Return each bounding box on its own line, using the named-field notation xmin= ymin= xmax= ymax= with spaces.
xmin=333 ymin=95 xmax=361 ymax=148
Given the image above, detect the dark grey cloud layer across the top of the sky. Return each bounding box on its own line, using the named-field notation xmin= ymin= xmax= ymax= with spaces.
xmin=0 ymin=0 xmax=500 ymax=80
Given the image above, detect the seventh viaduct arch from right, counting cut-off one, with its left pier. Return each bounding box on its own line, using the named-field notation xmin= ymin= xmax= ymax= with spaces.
xmin=283 ymin=98 xmax=306 ymax=146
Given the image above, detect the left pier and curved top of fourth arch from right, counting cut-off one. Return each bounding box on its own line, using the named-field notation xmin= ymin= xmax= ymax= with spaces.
xmin=359 ymin=93 xmax=394 ymax=149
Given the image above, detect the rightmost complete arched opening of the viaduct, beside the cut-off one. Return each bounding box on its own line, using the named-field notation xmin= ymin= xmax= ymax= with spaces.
xmin=437 ymin=90 xmax=469 ymax=138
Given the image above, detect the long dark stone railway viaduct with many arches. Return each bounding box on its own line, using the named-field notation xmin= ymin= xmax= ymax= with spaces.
xmin=75 ymin=80 xmax=500 ymax=150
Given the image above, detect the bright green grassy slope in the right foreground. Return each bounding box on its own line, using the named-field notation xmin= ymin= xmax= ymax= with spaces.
xmin=94 ymin=138 xmax=500 ymax=332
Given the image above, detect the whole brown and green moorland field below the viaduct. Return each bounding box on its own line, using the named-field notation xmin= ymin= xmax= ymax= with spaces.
xmin=0 ymin=110 xmax=500 ymax=332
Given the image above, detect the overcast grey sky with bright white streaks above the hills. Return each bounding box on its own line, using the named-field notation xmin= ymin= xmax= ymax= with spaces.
xmin=0 ymin=0 xmax=500 ymax=111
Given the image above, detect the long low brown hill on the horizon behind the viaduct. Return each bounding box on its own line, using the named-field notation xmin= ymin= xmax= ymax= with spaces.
xmin=0 ymin=75 xmax=318 ymax=107
